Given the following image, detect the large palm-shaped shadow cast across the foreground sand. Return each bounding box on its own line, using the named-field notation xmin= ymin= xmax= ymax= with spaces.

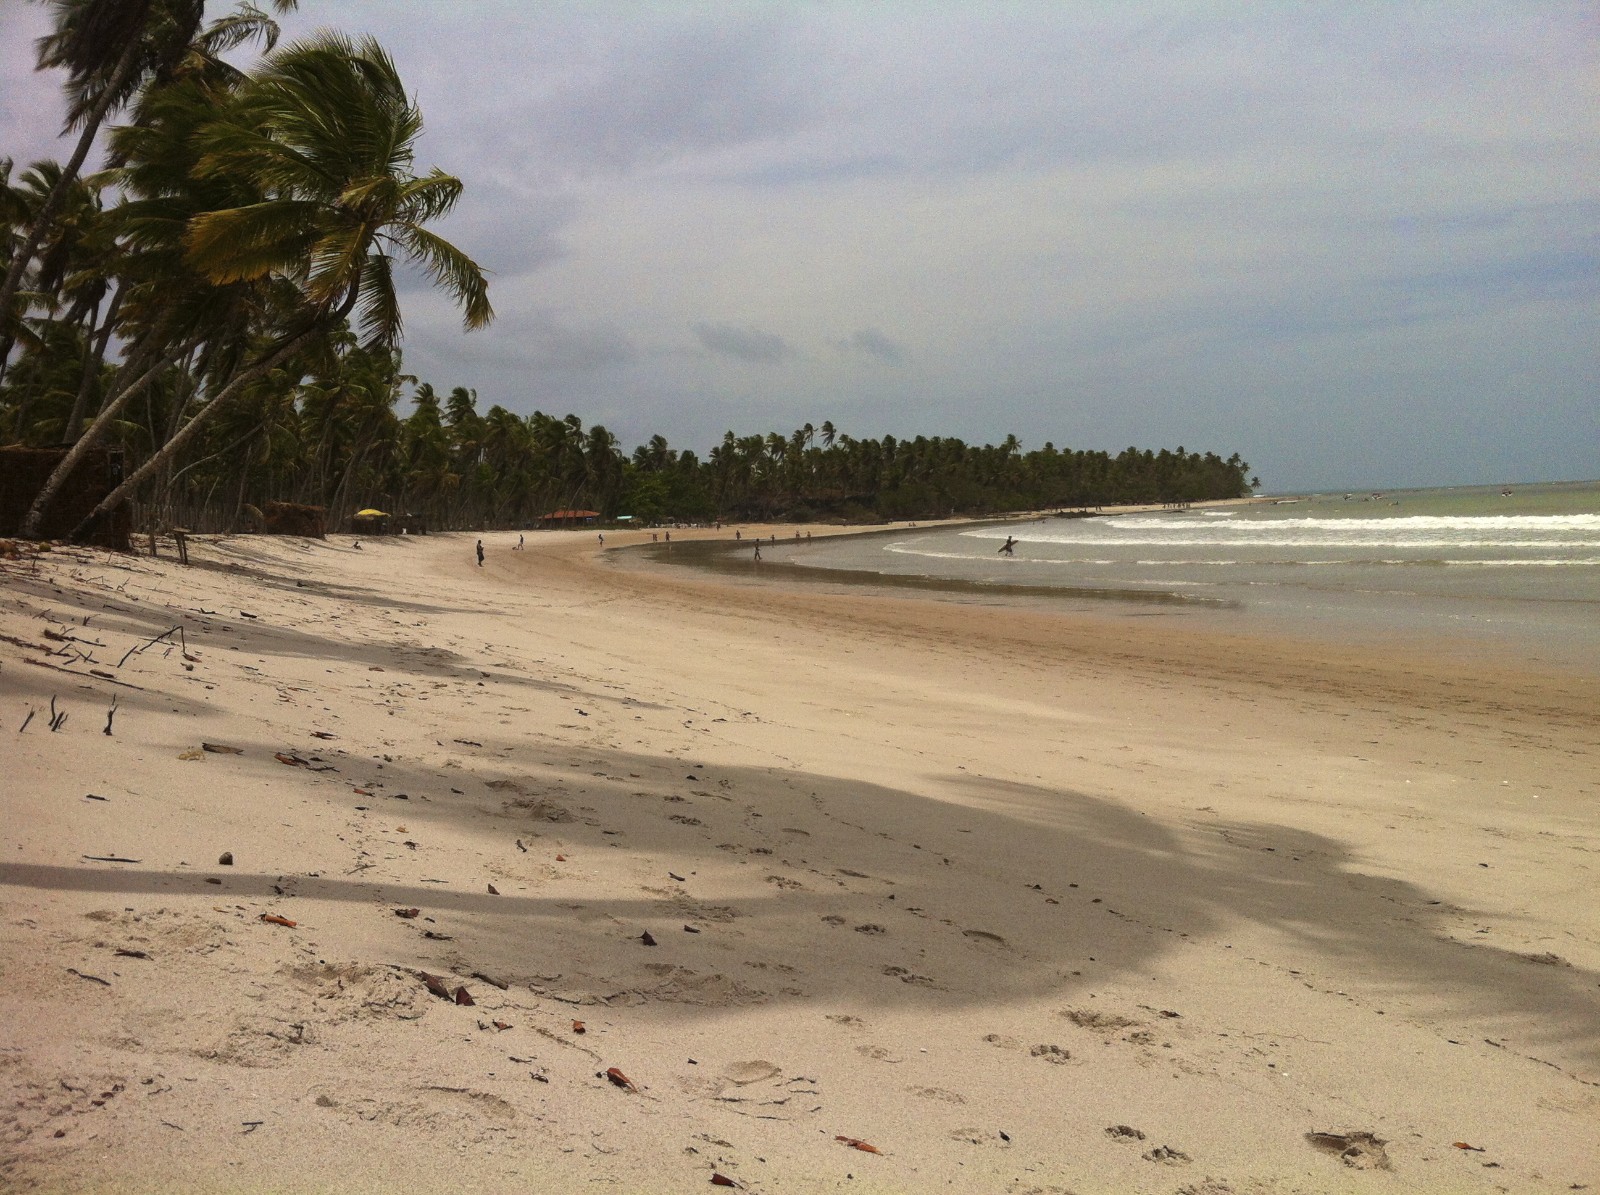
xmin=0 ymin=744 xmax=1600 ymax=1081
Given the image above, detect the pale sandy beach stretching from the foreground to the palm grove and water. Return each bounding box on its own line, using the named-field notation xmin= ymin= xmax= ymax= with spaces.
xmin=0 ymin=528 xmax=1600 ymax=1195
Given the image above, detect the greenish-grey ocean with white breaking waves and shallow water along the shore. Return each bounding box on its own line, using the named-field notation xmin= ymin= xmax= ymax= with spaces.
xmin=633 ymin=482 xmax=1600 ymax=673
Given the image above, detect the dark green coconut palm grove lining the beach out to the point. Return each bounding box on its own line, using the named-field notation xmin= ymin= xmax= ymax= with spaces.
xmin=0 ymin=0 xmax=1248 ymax=531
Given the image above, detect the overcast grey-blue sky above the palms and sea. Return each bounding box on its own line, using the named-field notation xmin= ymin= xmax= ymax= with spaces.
xmin=0 ymin=0 xmax=1600 ymax=491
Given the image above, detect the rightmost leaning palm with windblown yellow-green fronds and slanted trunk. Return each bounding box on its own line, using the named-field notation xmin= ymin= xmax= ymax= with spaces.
xmin=50 ymin=32 xmax=494 ymax=533
